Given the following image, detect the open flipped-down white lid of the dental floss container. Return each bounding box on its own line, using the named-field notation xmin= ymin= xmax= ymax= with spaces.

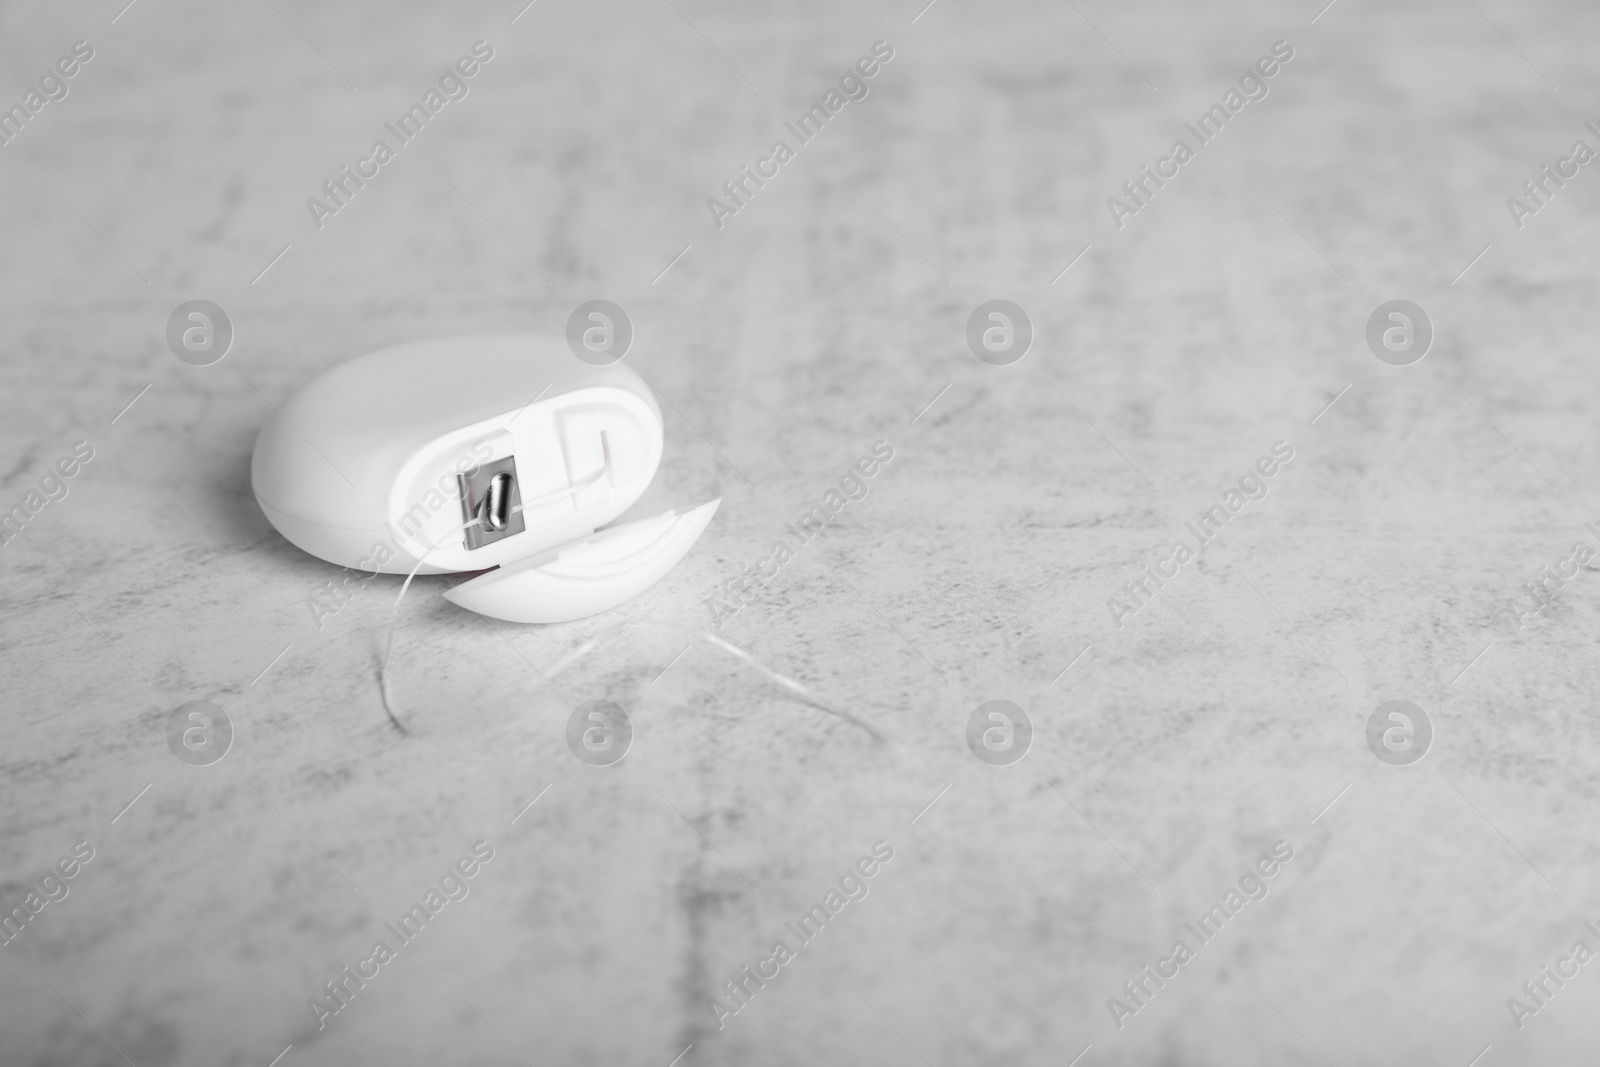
xmin=445 ymin=496 xmax=722 ymax=622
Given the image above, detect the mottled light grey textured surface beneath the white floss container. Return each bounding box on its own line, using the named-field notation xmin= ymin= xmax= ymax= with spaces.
xmin=0 ymin=0 xmax=1600 ymax=1067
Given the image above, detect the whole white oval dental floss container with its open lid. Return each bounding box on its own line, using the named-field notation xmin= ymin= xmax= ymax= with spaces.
xmin=250 ymin=334 xmax=720 ymax=622
